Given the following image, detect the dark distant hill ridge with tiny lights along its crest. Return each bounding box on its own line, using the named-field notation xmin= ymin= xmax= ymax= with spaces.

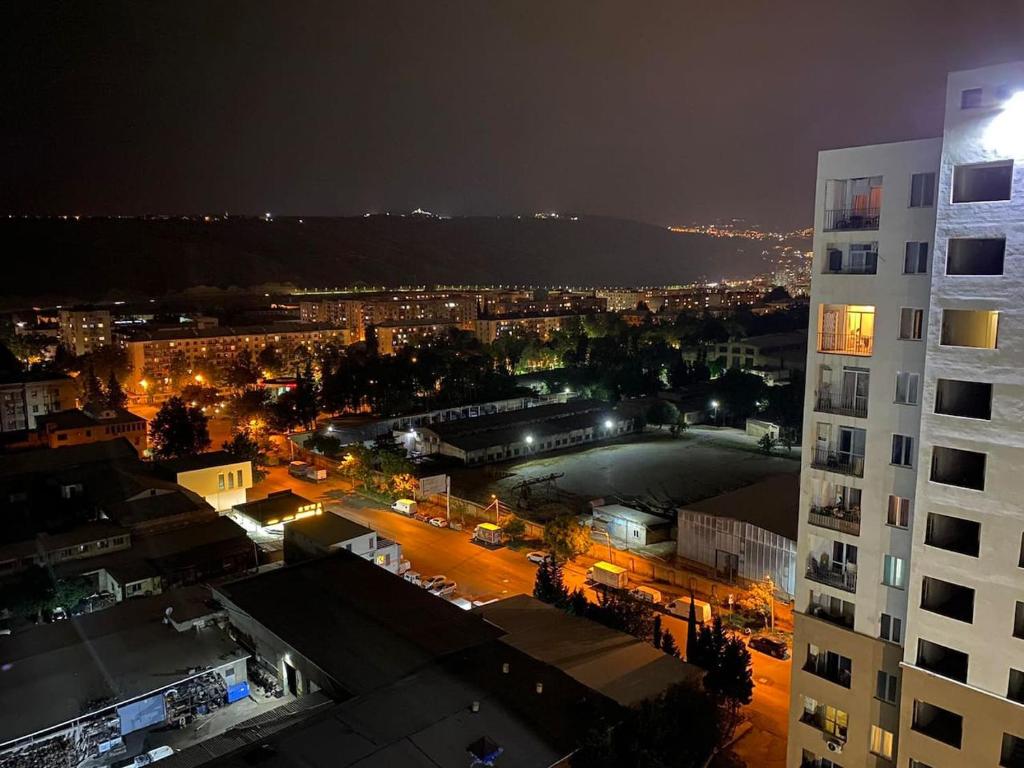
xmin=0 ymin=215 xmax=798 ymax=300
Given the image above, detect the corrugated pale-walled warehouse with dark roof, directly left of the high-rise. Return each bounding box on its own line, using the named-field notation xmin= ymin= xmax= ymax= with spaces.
xmin=676 ymin=474 xmax=800 ymax=597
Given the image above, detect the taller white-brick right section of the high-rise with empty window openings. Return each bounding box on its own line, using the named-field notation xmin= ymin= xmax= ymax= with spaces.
xmin=898 ymin=62 xmax=1024 ymax=768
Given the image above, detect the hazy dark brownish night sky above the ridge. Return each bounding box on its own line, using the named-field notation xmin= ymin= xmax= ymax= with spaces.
xmin=0 ymin=0 xmax=1024 ymax=226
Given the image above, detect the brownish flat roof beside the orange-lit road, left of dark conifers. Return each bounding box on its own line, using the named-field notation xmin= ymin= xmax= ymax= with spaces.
xmin=472 ymin=595 xmax=703 ymax=707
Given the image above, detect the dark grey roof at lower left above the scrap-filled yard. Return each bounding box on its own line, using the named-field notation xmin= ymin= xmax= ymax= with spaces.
xmin=0 ymin=587 xmax=243 ymax=742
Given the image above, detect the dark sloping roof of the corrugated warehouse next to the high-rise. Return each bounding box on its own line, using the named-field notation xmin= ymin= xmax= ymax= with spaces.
xmin=680 ymin=473 xmax=800 ymax=542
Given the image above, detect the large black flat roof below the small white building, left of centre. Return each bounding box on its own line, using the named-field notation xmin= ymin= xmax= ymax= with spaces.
xmin=214 ymin=550 xmax=501 ymax=694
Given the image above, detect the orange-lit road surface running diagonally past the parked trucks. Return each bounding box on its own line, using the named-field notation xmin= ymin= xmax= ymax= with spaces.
xmin=249 ymin=467 xmax=792 ymax=768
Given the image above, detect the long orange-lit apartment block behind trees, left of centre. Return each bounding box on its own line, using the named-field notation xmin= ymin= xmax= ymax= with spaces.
xmin=122 ymin=323 xmax=349 ymax=394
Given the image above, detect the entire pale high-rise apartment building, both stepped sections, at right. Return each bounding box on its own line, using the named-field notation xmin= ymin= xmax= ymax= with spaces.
xmin=787 ymin=63 xmax=1024 ymax=768
